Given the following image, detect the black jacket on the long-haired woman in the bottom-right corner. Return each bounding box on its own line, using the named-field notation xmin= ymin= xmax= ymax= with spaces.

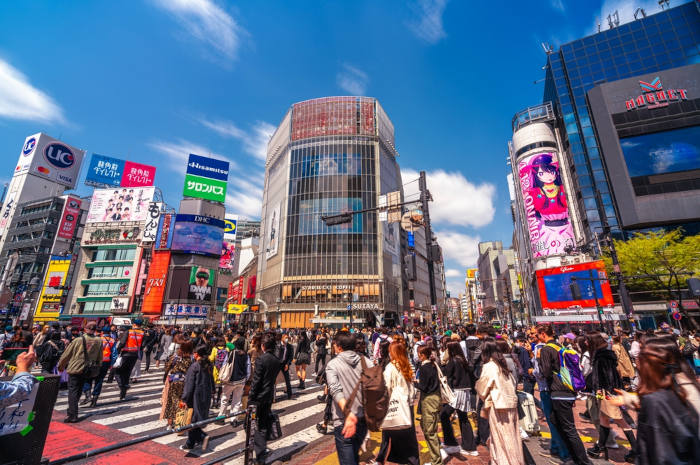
xmin=636 ymin=389 xmax=700 ymax=465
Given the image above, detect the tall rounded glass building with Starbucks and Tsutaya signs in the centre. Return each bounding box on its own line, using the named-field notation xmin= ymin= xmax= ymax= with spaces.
xmin=258 ymin=97 xmax=403 ymax=328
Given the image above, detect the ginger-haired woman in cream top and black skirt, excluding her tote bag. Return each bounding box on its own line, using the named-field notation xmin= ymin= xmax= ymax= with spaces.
xmin=368 ymin=337 xmax=419 ymax=465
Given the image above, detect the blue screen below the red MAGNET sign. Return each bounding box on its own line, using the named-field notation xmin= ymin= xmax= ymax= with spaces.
xmin=620 ymin=126 xmax=700 ymax=178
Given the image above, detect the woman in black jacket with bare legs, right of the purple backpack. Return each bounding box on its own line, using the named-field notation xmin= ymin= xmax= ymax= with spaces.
xmin=586 ymin=333 xmax=637 ymax=463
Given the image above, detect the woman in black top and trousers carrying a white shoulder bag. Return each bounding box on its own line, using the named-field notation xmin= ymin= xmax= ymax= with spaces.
xmin=440 ymin=341 xmax=479 ymax=456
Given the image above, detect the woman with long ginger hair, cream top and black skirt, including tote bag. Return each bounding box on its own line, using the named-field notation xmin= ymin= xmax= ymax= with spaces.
xmin=368 ymin=336 xmax=419 ymax=465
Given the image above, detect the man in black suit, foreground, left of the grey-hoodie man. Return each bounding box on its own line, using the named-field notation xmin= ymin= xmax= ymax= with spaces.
xmin=248 ymin=333 xmax=282 ymax=465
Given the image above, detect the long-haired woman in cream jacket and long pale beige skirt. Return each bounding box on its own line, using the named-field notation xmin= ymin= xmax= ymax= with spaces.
xmin=476 ymin=341 xmax=525 ymax=465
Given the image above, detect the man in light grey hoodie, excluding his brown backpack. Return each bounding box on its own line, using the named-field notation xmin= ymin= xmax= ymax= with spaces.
xmin=326 ymin=331 xmax=372 ymax=465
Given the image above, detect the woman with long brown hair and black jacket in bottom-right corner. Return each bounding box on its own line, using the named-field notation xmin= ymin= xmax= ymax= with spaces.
xmin=612 ymin=337 xmax=700 ymax=465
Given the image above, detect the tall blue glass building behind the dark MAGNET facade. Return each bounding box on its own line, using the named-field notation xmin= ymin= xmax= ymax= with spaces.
xmin=543 ymin=2 xmax=700 ymax=239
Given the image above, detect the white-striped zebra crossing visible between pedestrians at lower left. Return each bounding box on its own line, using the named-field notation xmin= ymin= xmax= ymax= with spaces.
xmin=49 ymin=360 xmax=325 ymax=464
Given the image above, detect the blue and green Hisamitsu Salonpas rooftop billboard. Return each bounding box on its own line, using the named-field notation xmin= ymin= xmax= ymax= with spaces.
xmin=183 ymin=154 xmax=229 ymax=203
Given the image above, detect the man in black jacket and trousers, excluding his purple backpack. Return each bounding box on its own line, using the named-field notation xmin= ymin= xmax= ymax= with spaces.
xmin=537 ymin=324 xmax=591 ymax=465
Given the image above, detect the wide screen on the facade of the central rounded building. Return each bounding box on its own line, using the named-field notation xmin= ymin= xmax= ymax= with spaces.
xmin=299 ymin=197 xmax=362 ymax=236
